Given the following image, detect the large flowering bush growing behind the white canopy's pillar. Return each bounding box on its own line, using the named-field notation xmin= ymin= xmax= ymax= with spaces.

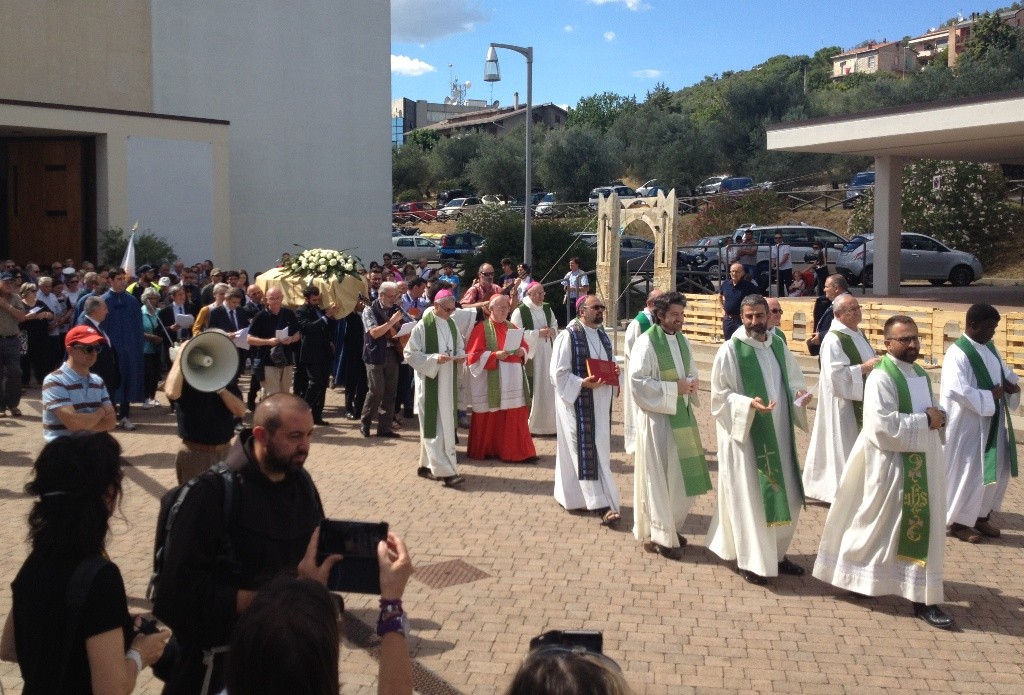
xmin=849 ymin=160 xmax=1019 ymax=265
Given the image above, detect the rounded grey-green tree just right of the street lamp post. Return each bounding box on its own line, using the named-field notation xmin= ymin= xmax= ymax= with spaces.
xmin=537 ymin=127 xmax=618 ymax=203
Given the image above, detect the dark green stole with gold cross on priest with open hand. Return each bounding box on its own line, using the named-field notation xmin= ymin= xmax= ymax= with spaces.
xmin=732 ymin=338 xmax=804 ymax=526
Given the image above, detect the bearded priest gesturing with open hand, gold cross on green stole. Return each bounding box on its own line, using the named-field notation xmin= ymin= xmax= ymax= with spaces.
xmin=708 ymin=295 xmax=808 ymax=584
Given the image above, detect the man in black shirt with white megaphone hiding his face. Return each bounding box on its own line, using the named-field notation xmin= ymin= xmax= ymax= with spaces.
xmin=164 ymin=330 xmax=246 ymax=485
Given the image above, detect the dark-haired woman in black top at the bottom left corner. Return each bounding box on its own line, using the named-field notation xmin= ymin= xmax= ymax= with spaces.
xmin=0 ymin=432 xmax=168 ymax=695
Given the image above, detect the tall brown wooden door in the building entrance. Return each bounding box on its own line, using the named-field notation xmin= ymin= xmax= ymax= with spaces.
xmin=4 ymin=139 xmax=84 ymax=267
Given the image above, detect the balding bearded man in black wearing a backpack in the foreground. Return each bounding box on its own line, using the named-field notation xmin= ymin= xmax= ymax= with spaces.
xmin=154 ymin=393 xmax=340 ymax=695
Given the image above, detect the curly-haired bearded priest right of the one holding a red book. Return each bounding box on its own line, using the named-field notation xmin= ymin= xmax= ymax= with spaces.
xmin=628 ymin=292 xmax=711 ymax=560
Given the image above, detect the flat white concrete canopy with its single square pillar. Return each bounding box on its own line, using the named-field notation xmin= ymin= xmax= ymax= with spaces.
xmin=767 ymin=91 xmax=1024 ymax=296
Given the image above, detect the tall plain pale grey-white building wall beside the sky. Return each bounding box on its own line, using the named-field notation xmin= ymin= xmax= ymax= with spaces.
xmin=151 ymin=0 xmax=391 ymax=273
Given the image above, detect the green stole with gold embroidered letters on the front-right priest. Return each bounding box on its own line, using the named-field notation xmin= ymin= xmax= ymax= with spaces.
xmin=874 ymin=355 xmax=933 ymax=567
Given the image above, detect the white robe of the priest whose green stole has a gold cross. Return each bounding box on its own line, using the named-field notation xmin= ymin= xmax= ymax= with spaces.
xmin=708 ymin=327 xmax=807 ymax=576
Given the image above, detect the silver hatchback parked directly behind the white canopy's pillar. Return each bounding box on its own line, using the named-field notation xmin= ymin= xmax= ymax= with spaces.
xmin=836 ymin=231 xmax=983 ymax=288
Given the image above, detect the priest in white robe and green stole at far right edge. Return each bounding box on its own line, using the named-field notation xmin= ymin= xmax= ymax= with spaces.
xmin=939 ymin=304 xmax=1021 ymax=542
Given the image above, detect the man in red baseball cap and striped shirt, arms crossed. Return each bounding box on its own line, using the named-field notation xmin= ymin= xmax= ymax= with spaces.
xmin=43 ymin=325 xmax=118 ymax=442
